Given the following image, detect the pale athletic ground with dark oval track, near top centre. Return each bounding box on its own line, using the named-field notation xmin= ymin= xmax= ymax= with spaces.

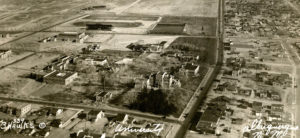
xmin=50 ymin=14 xmax=158 ymax=34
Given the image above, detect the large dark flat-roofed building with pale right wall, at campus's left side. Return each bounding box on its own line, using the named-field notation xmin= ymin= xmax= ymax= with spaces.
xmin=43 ymin=70 xmax=78 ymax=85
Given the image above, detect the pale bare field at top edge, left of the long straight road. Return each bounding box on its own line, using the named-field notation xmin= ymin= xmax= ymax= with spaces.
xmin=125 ymin=0 xmax=218 ymax=17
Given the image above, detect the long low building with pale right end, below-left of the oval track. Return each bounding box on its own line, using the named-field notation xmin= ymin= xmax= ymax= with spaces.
xmin=57 ymin=32 xmax=88 ymax=43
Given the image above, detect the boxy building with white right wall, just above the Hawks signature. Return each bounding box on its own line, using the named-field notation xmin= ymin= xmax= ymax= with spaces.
xmin=5 ymin=102 xmax=31 ymax=117
